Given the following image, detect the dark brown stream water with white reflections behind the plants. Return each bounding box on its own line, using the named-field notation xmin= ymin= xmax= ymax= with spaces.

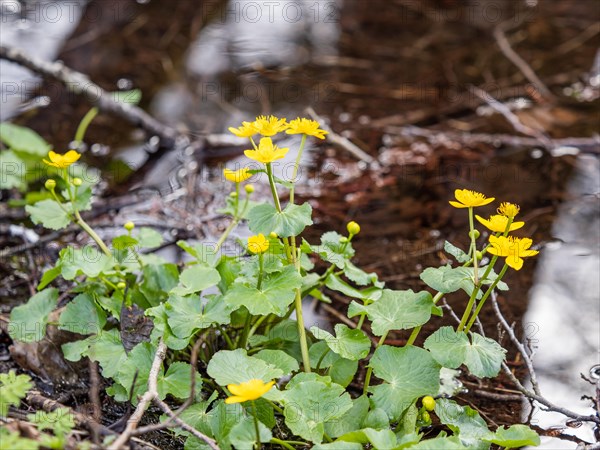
xmin=0 ymin=0 xmax=600 ymax=449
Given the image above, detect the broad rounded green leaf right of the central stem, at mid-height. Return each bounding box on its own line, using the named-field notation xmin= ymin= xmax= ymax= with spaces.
xmin=356 ymin=289 xmax=433 ymax=336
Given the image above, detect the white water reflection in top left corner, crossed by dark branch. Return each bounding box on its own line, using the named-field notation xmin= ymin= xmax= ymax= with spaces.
xmin=0 ymin=0 xmax=87 ymax=121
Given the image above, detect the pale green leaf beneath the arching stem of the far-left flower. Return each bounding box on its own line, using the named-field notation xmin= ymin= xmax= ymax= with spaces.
xmin=58 ymin=245 xmax=115 ymax=280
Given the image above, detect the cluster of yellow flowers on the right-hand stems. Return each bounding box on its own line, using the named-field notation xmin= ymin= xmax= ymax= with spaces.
xmin=449 ymin=189 xmax=539 ymax=270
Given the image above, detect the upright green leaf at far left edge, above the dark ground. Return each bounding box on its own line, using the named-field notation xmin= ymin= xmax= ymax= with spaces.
xmin=8 ymin=288 xmax=58 ymax=342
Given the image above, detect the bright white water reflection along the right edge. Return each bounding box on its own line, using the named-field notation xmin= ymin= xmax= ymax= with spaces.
xmin=525 ymin=155 xmax=600 ymax=449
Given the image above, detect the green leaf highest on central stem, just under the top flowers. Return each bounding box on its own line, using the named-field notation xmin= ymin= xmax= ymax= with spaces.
xmin=248 ymin=203 xmax=313 ymax=237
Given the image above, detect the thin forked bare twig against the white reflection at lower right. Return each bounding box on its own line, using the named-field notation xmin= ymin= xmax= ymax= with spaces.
xmin=492 ymin=294 xmax=600 ymax=424
